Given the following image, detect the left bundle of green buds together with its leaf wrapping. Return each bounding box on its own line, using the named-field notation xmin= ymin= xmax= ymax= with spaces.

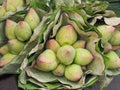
xmin=0 ymin=0 xmax=46 ymax=74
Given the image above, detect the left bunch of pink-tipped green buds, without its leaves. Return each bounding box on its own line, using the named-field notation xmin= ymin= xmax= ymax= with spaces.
xmin=0 ymin=6 xmax=40 ymax=67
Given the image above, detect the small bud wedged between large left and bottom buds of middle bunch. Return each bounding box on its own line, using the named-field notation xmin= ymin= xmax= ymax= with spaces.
xmin=52 ymin=64 xmax=65 ymax=76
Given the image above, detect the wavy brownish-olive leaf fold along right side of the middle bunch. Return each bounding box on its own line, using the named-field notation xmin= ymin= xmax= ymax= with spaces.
xmin=86 ymin=35 xmax=105 ymax=75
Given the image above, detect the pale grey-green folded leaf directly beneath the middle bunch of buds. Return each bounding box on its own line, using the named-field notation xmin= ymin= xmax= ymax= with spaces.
xmin=26 ymin=68 xmax=85 ymax=89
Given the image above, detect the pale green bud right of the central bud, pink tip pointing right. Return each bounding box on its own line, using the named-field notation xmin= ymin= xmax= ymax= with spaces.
xmin=74 ymin=48 xmax=93 ymax=65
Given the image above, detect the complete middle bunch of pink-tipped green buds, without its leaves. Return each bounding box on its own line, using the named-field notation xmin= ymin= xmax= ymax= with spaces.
xmin=37 ymin=25 xmax=94 ymax=81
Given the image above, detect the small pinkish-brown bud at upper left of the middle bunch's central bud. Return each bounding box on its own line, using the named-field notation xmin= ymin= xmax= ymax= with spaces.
xmin=46 ymin=39 xmax=60 ymax=53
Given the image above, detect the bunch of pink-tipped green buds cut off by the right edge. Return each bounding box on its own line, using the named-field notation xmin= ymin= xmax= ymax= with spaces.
xmin=97 ymin=25 xmax=120 ymax=69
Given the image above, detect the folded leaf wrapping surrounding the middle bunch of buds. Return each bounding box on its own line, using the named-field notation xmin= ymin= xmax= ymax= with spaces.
xmin=19 ymin=6 xmax=104 ymax=90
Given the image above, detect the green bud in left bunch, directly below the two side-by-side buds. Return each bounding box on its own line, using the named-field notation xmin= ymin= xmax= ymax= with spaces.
xmin=8 ymin=39 xmax=25 ymax=55
